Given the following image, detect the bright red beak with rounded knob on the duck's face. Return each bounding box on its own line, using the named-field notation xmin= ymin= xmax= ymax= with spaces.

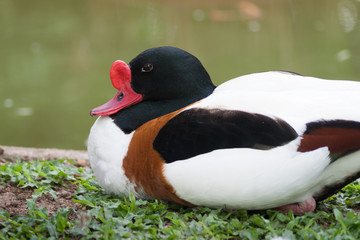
xmin=90 ymin=60 xmax=143 ymax=115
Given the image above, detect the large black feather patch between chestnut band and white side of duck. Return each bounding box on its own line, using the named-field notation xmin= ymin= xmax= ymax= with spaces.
xmin=154 ymin=108 xmax=298 ymax=163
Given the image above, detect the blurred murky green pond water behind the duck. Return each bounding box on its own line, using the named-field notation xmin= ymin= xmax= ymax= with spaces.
xmin=0 ymin=0 xmax=360 ymax=149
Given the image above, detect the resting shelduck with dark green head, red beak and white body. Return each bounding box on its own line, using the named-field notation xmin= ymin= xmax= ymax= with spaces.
xmin=87 ymin=46 xmax=360 ymax=215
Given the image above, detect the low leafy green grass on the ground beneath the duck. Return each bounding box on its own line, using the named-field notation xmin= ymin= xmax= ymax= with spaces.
xmin=0 ymin=160 xmax=360 ymax=239
